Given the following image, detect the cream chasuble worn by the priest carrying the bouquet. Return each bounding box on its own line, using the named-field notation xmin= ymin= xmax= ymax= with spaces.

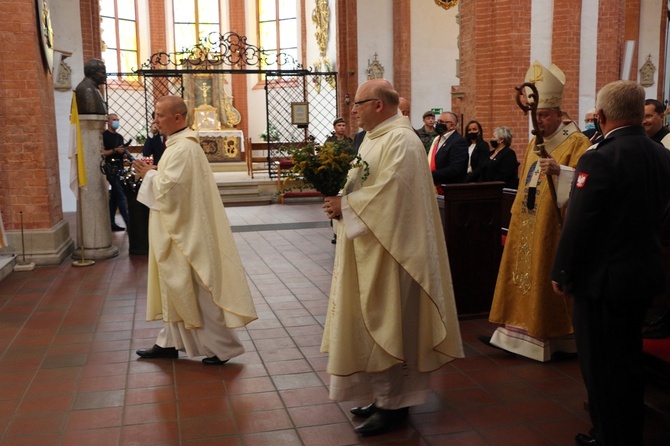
xmin=321 ymin=117 xmax=463 ymax=376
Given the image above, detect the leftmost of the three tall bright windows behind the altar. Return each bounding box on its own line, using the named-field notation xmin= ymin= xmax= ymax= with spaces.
xmin=100 ymin=0 xmax=139 ymax=73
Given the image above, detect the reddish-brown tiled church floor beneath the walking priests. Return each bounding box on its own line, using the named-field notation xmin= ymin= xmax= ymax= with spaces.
xmin=0 ymin=203 xmax=670 ymax=446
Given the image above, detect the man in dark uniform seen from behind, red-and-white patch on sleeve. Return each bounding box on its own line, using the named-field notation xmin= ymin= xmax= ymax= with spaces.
xmin=551 ymin=81 xmax=670 ymax=446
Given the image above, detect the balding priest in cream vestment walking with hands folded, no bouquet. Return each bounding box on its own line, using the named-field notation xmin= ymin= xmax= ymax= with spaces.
xmin=133 ymin=96 xmax=257 ymax=365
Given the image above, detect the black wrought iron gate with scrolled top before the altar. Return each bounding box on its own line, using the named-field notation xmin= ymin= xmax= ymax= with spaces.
xmin=106 ymin=33 xmax=338 ymax=178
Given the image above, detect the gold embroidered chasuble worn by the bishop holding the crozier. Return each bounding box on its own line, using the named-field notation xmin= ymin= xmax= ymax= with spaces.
xmin=489 ymin=123 xmax=591 ymax=339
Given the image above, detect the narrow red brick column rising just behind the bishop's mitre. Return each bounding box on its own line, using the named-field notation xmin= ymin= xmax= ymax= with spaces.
xmin=551 ymin=0 xmax=582 ymax=125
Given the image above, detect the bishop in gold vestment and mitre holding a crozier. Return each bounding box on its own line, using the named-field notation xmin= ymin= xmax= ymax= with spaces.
xmin=480 ymin=62 xmax=591 ymax=362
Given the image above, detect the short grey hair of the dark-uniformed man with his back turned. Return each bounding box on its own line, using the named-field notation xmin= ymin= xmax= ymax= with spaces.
xmin=596 ymin=81 xmax=645 ymax=125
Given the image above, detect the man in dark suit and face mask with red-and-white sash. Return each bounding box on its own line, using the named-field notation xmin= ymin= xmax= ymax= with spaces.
xmin=428 ymin=112 xmax=469 ymax=193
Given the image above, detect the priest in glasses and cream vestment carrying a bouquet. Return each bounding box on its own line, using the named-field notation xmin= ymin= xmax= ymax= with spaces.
xmin=321 ymin=79 xmax=463 ymax=435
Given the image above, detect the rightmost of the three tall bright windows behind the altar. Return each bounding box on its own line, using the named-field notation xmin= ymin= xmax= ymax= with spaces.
xmin=258 ymin=0 xmax=299 ymax=69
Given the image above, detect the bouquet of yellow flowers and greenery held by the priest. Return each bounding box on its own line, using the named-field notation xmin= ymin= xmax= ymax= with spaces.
xmin=281 ymin=141 xmax=370 ymax=197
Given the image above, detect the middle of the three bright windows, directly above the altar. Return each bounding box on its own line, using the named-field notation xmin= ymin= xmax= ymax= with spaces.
xmin=172 ymin=0 xmax=221 ymax=51
